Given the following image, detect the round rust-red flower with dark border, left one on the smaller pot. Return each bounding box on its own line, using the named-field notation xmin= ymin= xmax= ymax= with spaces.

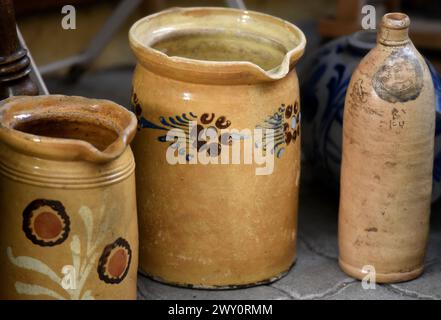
xmin=23 ymin=199 xmax=70 ymax=247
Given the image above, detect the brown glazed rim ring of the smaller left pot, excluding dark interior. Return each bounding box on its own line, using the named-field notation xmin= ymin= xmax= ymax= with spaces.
xmin=0 ymin=95 xmax=137 ymax=163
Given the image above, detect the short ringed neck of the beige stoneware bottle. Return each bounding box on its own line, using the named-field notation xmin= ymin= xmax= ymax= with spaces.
xmin=377 ymin=13 xmax=410 ymax=46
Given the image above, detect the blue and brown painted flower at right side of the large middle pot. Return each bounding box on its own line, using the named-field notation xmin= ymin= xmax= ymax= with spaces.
xmin=256 ymin=101 xmax=301 ymax=158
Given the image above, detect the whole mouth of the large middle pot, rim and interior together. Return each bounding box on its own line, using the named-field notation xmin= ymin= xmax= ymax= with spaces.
xmin=129 ymin=7 xmax=306 ymax=84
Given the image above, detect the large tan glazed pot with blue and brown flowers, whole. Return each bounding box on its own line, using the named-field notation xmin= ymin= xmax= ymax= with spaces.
xmin=130 ymin=8 xmax=306 ymax=288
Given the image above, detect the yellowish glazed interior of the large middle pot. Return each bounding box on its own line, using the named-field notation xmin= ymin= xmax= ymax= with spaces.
xmin=151 ymin=30 xmax=287 ymax=71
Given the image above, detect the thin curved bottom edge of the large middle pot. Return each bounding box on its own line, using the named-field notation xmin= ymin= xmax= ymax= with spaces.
xmin=138 ymin=260 xmax=296 ymax=290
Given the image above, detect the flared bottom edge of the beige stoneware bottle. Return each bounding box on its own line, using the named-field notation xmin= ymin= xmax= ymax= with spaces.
xmin=338 ymin=259 xmax=424 ymax=283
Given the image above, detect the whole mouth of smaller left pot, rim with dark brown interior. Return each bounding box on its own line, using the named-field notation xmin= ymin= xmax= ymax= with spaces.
xmin=0 ymin=95 xmax=137 ymax=163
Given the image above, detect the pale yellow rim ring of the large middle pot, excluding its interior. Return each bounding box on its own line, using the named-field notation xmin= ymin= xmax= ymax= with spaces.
xmin=129 ymin=7 xmax=306 ymax=84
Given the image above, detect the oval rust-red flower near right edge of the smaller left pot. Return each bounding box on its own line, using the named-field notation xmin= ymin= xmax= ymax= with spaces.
xmin=98 ymin=238 xmax=132 ymax=284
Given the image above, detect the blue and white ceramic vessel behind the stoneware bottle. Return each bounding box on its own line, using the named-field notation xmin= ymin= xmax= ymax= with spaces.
xmin=299 ymin=31 xmax=441 ymax=202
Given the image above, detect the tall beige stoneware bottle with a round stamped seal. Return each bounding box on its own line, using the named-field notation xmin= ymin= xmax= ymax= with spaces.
xmin=339 ymin=13 xmax=435 ymax=283
